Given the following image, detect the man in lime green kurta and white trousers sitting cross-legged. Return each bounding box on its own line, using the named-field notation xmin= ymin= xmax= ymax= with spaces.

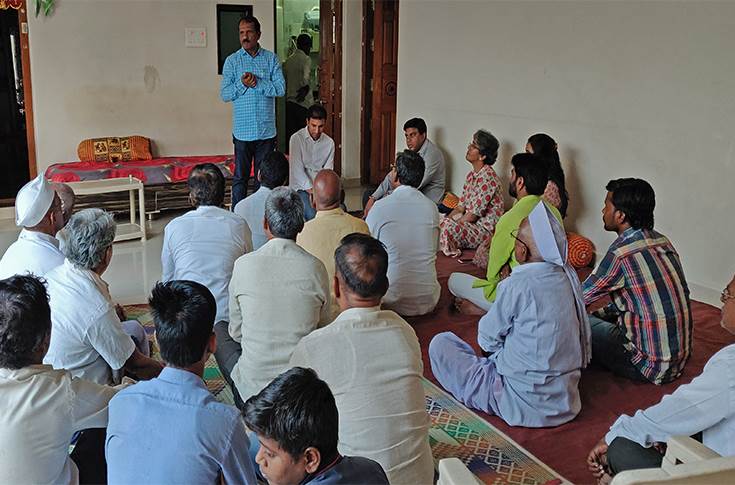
xmin=448 ymin=153 xmax=561 ymax=315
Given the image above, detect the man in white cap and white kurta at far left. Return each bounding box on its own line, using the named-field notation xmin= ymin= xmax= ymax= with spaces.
xmin=0 ymin=174 xmax=64 ymax=278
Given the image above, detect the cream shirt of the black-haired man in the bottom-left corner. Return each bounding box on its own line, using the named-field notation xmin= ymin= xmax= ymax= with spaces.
xmin=0 ymin=365 xmax=117 ymax=484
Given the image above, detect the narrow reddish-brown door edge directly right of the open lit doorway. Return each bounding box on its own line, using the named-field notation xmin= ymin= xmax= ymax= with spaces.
xmin=319 ymin=0 xmax=342 ymax=174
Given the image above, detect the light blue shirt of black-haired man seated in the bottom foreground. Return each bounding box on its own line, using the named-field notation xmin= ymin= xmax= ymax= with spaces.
xmin=105 ymin=367 xmax=256 ymax=484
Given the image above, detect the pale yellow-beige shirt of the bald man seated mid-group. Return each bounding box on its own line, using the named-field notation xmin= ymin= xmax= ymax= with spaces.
xmin=296 ymin=207 xmax=370 ymax=317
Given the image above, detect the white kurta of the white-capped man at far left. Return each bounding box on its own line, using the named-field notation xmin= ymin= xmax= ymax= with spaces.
xmin=0 ymin=229 xmax=64 ymax=279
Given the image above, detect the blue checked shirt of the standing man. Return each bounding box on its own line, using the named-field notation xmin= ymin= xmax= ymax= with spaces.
xmin=219 ymin=47 xmax=286 ymax=141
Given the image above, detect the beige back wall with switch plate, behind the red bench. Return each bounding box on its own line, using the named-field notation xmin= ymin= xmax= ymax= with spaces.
xmin=29 ymin=0 xmax=274 ymax=172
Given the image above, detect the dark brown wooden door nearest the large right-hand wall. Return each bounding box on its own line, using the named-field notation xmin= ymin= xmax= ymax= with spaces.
xmin=361 ymin=0 xmax=398 ymax=184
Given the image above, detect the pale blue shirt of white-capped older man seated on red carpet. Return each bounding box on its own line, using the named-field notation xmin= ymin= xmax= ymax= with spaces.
xmin=477 ymin=262 xmax=582 ymax=427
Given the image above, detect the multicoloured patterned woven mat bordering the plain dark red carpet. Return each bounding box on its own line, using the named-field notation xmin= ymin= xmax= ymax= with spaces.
xmin=125 ymin=305 xmax=569 ymax=485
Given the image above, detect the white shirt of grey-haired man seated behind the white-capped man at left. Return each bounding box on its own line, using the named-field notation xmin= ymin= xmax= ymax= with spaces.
xmin=43 ymin=260 xmax=135 ymax=384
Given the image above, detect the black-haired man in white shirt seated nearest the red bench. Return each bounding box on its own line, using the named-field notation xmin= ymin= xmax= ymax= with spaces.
xmin=161 ymin=163 xmax=250 ymax=322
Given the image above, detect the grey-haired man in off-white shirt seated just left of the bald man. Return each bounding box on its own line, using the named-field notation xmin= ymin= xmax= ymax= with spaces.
xmin=214 ymin=187 xmax=330 ymax=409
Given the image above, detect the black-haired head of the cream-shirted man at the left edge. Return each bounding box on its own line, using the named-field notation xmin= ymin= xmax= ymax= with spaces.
xmin=0 ymin=275 xmax=51 ymax=369
